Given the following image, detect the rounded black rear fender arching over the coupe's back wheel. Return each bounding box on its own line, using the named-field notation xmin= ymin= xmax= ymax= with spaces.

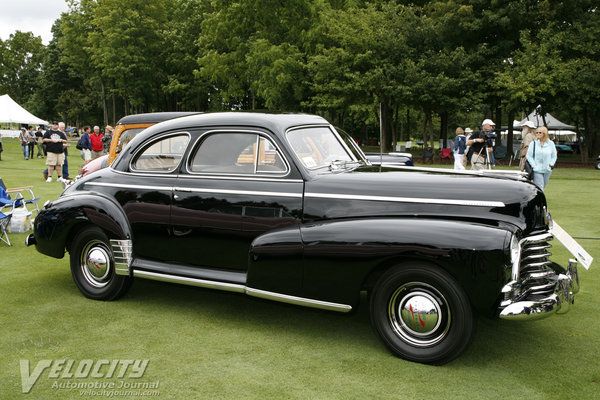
xmin=34 ymin=192 xmax=132 ymax=258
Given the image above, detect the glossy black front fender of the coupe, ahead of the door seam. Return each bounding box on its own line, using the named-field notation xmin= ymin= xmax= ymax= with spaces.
xmin=301 ymin=218 xmax=511 ymax=312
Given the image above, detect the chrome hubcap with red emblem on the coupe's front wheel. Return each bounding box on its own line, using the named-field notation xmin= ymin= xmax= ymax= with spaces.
xmin=388 ymin=282 xmax=451 ymax=347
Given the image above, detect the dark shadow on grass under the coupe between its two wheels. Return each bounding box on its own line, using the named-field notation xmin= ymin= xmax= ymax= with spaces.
xmin=125 ymin=279 xmax=385 ymax=351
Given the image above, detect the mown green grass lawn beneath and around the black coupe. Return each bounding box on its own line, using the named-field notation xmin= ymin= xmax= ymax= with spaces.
xmin=0 ymin=139 xmax=600 ymax=400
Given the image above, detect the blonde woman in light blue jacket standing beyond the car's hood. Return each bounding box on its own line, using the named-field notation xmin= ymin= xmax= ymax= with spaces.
xmin=527 ymin=126 xmax=556 ymax=190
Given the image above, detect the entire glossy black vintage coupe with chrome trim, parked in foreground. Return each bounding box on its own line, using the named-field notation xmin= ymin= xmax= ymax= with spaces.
xmin=28 ymin=113 xmax=579 ymax=364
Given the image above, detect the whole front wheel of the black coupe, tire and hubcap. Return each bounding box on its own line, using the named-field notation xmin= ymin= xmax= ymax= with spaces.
xmin=370 ymin=263 xmax=475 ymax=365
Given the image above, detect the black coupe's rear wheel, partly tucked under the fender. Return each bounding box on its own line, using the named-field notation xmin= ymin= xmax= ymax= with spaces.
xmin=71 ymin=226 xmax=133 ymax=300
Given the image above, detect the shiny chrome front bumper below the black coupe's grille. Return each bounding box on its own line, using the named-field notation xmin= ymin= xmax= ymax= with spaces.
xmin=500 ymin=260 xmax=579 ymax=321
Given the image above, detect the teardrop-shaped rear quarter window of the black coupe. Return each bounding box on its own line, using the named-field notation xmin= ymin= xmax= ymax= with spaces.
xmin=132 ymin=135 xmax=189 ymax=172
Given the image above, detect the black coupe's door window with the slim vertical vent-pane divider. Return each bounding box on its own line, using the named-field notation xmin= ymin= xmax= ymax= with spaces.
xmin=190 ymin=133 xmax=287 ymax=174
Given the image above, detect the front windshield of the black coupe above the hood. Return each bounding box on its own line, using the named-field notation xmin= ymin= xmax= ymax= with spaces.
xmin=287 ymin=127 xmax=360 ymax=169
